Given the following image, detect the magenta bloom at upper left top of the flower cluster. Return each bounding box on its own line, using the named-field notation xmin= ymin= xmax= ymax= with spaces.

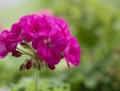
xmin=19 ymin=14 xmax=42 ymax=42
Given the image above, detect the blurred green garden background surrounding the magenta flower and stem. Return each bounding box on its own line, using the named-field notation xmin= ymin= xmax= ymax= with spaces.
xmin=0 ymin=0 xmax=120 ymax=91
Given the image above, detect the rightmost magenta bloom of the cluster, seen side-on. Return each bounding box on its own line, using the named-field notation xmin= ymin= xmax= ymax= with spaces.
xmin=64 ymin=37 xmax=80 ymax=67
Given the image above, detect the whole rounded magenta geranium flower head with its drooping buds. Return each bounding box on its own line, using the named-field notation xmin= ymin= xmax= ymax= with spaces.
xmin=0 ymin=14 xmax=80 ymax=70
